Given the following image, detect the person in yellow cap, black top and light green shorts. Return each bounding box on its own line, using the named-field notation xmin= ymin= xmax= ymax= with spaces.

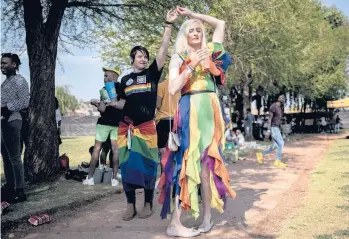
xmin=83 ymin=68 xmax=122 ymax=186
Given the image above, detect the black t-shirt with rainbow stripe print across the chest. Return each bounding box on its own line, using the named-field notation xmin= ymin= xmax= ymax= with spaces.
xmin=119 ymin=60 xmax=162 ymax=125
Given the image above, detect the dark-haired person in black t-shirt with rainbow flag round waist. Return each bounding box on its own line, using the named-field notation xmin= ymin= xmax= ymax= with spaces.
xmin=113 ymin=10 xmax=178 ymax=221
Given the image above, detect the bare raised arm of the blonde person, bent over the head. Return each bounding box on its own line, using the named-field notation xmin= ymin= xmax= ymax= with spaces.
xmin=177 ymin=7 xmax=225 ymax=43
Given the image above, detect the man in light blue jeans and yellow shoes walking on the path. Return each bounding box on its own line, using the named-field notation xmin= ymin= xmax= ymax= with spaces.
xmin=256 ymin=95 xmax=287 ymax=168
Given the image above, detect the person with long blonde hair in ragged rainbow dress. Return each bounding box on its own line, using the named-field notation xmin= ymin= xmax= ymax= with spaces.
xmin=158 ymin=7 xmax=235 ymax=237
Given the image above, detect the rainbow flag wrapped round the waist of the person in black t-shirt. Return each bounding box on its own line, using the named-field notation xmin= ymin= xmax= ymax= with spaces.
xmin=118 ymin=120 xmax=159 ymax=191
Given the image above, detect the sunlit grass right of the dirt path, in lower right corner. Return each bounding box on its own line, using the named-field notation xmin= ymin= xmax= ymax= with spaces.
xmin=278 ymin=139 xmax=349 ymax=239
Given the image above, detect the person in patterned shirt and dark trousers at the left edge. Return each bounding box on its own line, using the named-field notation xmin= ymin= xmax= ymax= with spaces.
xmin=1 ymin=53 xmax=29 ymax=203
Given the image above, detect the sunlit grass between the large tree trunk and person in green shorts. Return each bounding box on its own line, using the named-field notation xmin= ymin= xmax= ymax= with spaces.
xmin=59 ymin=136 xmax=95 ymax=168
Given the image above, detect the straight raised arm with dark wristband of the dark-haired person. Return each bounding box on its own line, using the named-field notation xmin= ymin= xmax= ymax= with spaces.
xmin=156 ymin=10 xmax=178 ymax=70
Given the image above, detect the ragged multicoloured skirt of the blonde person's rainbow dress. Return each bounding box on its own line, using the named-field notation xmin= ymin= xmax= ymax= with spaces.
xmin=158 ymin=90 xmax=236 ymax=219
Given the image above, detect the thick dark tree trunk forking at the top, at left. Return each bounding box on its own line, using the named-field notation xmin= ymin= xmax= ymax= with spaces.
xmin=23 ymin=0 xmax=67 ymax=182
